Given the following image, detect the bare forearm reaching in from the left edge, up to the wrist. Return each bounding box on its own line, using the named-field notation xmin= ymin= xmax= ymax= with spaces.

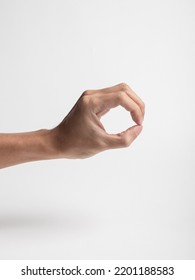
xmin=0 ymin=129 xmax=57 ymax=168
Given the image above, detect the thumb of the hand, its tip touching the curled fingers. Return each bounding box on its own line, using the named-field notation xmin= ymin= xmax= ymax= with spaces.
xmin=108 ymin=125 xmax=143 ymax=149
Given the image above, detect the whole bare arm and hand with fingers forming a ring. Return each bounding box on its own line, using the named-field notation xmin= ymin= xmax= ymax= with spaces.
xmin=0 ymin=83 xmax=145 ymax=168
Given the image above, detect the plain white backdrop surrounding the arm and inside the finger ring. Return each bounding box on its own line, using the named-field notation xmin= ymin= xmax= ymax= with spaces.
xmin=0 ymin=0 xmax=195 ymax=259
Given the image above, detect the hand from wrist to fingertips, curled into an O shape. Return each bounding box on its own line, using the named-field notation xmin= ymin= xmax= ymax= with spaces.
xmin=52 ymin=83 xmax=145 ymax=158
